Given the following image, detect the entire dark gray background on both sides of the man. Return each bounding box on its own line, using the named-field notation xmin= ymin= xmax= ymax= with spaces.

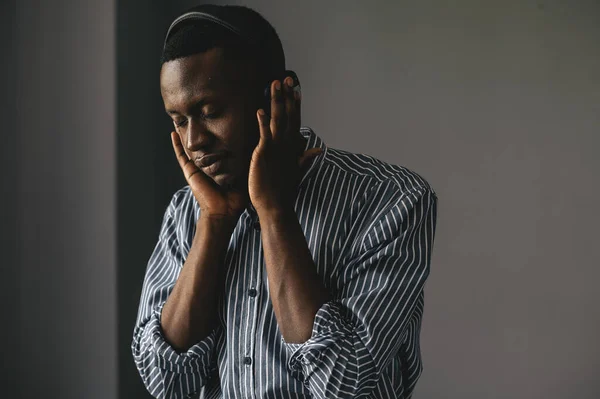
xmin=0 ymin=0 xmax=600 ymax=399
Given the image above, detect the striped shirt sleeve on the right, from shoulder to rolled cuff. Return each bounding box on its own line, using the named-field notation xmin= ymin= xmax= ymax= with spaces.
xmin=282 ymin=188 xmax=437 ymax=398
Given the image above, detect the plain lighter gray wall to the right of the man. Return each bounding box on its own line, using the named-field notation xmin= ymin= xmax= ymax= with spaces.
xmin=156 ymin=0 xmax=600 ymax=399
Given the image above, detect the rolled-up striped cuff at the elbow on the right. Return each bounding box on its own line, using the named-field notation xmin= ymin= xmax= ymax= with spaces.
xmin=281 ymin=301 xmax=354 ymax=384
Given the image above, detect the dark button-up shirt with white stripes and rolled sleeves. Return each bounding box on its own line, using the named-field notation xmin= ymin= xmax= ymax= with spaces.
xmin=132 ymin=127 xmax=437 ymax=399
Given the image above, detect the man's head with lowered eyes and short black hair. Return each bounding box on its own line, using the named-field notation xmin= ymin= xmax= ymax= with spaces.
xmin=160 ymin=6 xmax=285 ymax=189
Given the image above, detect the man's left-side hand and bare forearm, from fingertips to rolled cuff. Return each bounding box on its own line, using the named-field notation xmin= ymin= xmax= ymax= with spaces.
xmin=160 ymin=132 xmax=249 ymax=353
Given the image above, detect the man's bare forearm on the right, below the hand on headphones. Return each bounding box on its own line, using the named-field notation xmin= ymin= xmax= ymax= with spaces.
xmin=259 ymin=209 xmax=330 ymax=343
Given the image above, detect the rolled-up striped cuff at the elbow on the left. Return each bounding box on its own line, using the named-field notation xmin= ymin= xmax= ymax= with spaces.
xmin=148 ymin=303 xmax=216 ymax=376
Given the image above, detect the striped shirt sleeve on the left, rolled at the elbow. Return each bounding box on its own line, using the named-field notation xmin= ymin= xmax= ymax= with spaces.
xmin=131 ymin=194 xmax=216 ymax=398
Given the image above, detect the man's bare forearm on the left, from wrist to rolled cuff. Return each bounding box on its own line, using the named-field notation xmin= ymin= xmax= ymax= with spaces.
xmin=161 ymin=217 xmax=233 ymax=352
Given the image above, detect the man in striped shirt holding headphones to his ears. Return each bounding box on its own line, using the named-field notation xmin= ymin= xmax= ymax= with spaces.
xmin=132 ymin=6 xmax=437 ymax=398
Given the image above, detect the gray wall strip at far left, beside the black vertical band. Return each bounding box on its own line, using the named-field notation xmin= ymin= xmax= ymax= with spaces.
xmin=0 ymin=0 xmax=117 ymax=399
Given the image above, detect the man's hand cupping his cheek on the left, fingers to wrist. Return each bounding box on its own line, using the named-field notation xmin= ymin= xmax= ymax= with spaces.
xmin=171 ymin=132 xmax=250 ymax=225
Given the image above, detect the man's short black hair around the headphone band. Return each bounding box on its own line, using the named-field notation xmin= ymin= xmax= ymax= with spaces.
xmin=161 ymin=6 xmax=285 ymax=83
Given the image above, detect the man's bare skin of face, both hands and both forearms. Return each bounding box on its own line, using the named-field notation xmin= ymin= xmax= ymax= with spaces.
xmin=160 ymin=48 xmax=330 ymax=351
